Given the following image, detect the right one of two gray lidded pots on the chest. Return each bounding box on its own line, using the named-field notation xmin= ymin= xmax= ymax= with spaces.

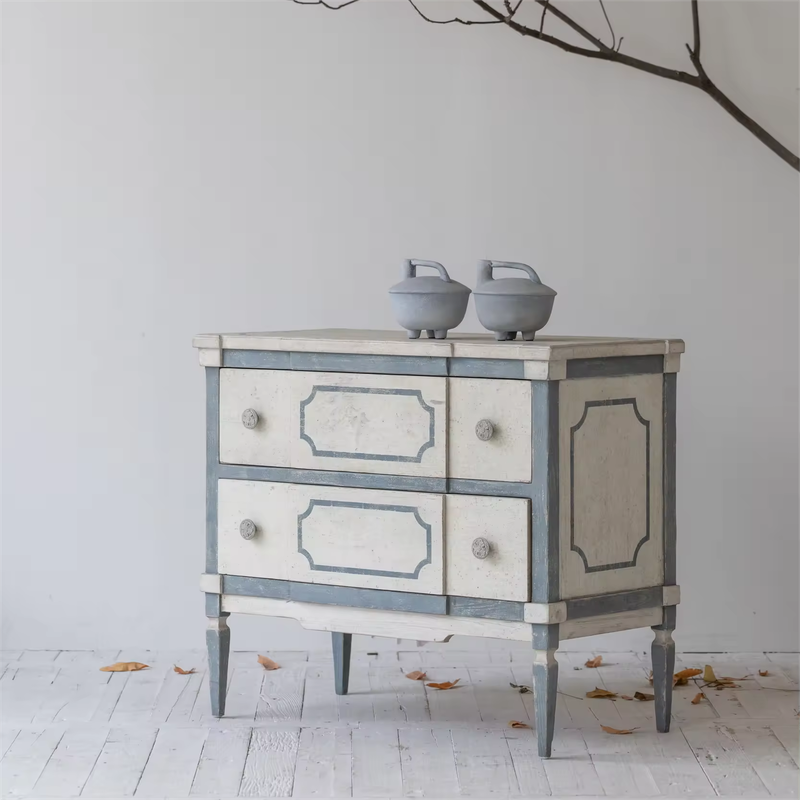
xmin=475 ymin=261 xmax=556 ymax=342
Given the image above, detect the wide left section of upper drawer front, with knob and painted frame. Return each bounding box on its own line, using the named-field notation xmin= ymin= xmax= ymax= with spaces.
xmin=220 ymin=369 xmax=447 ymax=478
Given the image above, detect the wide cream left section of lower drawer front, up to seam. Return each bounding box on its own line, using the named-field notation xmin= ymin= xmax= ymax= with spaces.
xmin=219 ymin=480 xmax=444 ymax=594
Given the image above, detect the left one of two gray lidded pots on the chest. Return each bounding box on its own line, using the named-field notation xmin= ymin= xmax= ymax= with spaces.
xmin=389 ymin=259 xmax=470 ymax=339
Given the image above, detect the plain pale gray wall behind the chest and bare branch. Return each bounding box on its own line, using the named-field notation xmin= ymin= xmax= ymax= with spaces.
xmin=0 ymin=0 xmax=800 ymax=650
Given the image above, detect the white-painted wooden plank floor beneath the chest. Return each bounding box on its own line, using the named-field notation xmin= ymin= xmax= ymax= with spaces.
xmin=0 ymin=649 xmax=800 ymax=800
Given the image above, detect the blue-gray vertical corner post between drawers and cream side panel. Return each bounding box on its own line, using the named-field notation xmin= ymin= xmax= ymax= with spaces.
xmin=530 ymin=381 xmax=560 ymax=603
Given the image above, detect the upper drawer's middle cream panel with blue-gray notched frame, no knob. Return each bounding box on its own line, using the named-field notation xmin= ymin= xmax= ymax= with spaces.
xmin=290 ymin=372 xmax=447 ymax=477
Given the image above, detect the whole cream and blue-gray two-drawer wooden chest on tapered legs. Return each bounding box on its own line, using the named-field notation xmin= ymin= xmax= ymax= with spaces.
xmin=194 ymin=330 xmax=684 ymax=756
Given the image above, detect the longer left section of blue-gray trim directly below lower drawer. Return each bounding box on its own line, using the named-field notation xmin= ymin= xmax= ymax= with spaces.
xmin=222 ymin=575 xmax=447 ymax=614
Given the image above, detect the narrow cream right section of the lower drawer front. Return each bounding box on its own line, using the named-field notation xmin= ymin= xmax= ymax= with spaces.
xmin=445 ymin=494 xmax=531 ymax=603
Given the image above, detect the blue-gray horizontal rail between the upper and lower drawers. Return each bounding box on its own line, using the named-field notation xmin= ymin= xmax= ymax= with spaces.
xmin=219 ymin=464 xmax=531 ymax=498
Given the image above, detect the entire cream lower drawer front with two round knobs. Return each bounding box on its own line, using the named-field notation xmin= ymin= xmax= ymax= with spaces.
xmin=218 ymin=480 xmax=530 ymax=601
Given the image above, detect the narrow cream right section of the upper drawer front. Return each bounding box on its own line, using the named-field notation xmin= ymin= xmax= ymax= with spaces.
xmin=448 ymin=378 xmax=532 ymax=483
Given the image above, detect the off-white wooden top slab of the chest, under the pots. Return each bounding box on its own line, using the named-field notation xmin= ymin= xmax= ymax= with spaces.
xmin=193 ymin=328 xmax=684 ymax=361
